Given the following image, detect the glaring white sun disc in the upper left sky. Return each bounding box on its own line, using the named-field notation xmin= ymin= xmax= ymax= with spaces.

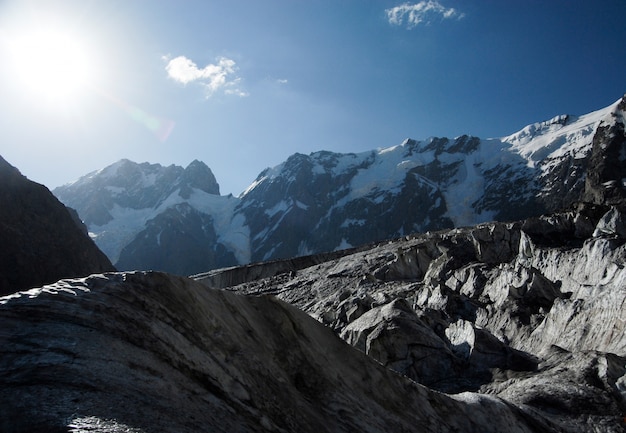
xmin=6 ymin=25 xmax=97 ymax=105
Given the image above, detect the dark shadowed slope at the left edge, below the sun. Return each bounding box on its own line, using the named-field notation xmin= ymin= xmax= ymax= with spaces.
xmin=0 ymin=157 xmax=114 ymax=295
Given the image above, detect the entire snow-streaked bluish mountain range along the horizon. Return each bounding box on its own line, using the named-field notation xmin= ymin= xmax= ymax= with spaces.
xmin=54 ymin=96 xmax=626 ymax=275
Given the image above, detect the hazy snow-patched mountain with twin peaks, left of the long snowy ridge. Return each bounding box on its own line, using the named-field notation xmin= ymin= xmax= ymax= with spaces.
xmin=54 ymin=160 xmax=250 ymax=274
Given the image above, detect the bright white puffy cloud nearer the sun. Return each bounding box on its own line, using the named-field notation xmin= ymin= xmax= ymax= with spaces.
xmin=164 ymin=56 xmax=248 ymax=98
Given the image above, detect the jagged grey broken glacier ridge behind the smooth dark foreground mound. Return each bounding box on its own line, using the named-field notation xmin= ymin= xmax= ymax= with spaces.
xmin=195 ymin=204 xmax=626 ymax=432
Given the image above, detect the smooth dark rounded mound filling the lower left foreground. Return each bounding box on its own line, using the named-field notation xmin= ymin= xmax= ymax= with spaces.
xmin=0 ymin=273 xmax=556 ymax=433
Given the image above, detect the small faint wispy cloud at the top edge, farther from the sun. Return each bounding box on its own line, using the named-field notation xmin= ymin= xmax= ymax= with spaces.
xmin=385 ymin=0 xmax=465 ymax=29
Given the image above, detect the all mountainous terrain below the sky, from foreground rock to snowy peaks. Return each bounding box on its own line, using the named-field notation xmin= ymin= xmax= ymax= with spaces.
xmin=0 ymin=93 xmax=626 ymax=433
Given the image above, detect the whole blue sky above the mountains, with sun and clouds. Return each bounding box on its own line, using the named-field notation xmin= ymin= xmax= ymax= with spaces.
xmin=0 ymin=0 xmax=626 ymax=195
